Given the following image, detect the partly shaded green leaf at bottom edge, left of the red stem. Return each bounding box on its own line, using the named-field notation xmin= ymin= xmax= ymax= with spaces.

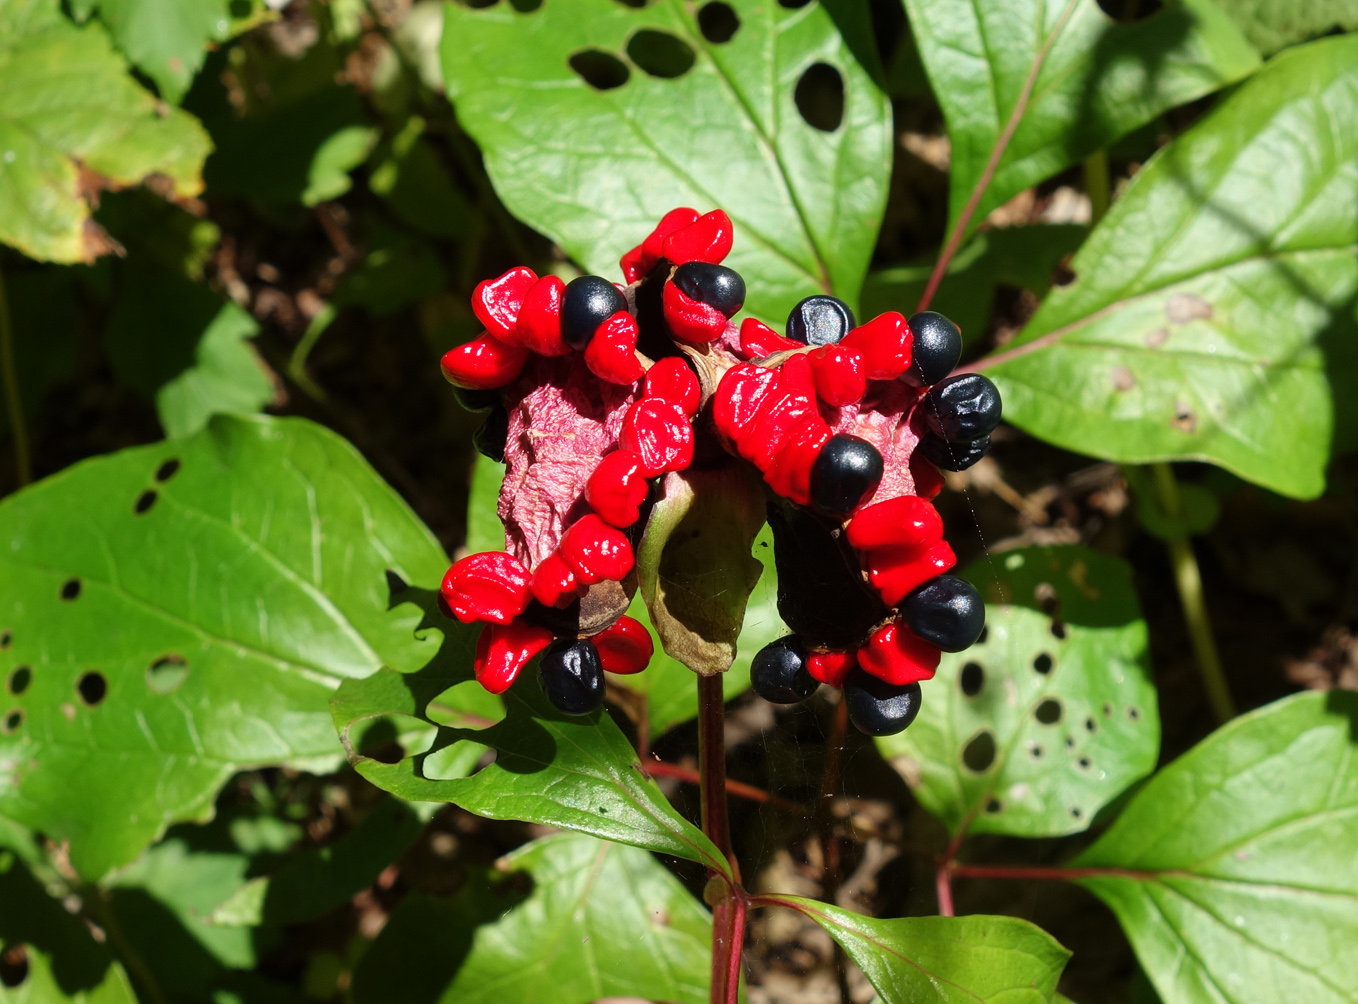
xmin=353 ymin=834 xmax=712 ymax=1004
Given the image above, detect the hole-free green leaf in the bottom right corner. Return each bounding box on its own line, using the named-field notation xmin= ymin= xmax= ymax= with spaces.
xmin=1071 ymin=690 xmax=1358 ymax=1004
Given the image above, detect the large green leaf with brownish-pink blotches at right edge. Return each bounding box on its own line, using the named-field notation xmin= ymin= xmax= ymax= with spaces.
xmin=982 ymin=37 xmax=1358 ymax=499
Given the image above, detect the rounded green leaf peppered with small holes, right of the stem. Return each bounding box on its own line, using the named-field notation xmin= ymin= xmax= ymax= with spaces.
xmin=877 ymin=548 xmax=1160 ymax=837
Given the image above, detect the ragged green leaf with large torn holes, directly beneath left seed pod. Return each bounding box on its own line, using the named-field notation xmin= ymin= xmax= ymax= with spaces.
xmin=331 ymin=616 xmax=728 ymax=871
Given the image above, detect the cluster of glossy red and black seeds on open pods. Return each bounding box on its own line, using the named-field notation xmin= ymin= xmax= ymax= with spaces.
xmin=443 ymin=209 xmax=999 ymax=735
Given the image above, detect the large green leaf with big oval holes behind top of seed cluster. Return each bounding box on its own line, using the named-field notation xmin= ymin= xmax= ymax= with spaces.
xmin=443 ymin=0 xmax=891 ymax=317
